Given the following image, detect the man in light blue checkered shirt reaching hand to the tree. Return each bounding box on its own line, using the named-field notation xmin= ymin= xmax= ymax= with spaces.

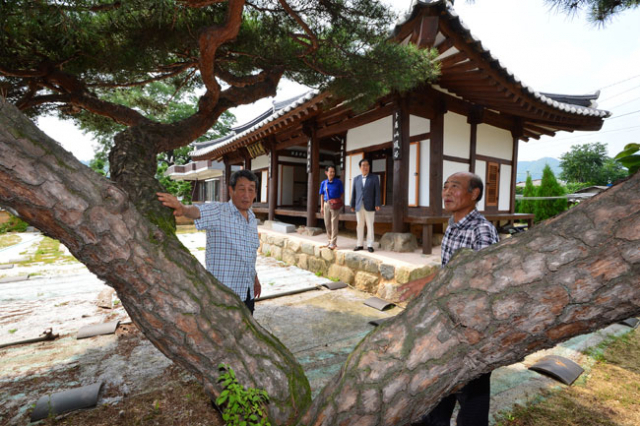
xmin=157 ymin=170 xmax=261 ymax=314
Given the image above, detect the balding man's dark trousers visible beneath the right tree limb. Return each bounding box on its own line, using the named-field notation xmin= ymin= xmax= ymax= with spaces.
xmin=413 ymin=373 xmax=491 ymax=426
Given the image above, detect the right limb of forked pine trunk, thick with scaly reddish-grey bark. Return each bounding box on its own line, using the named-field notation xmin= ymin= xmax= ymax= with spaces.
xmin=302 ymin=173 xmax=640 ymax=426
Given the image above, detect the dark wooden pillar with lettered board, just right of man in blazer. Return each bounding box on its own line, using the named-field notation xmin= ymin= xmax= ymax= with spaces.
xmin=391 ymin=101 xmax=410 ymax=232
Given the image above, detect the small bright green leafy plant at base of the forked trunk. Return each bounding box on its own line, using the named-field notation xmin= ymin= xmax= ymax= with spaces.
xmin=216 ymin=364 xmax=271 ymax=426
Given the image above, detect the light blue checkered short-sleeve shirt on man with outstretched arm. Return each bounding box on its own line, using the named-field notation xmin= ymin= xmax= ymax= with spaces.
xmin=195 ymin=201 xmax=260 ymax=300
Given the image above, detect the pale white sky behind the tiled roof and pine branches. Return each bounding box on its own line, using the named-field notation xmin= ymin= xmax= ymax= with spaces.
xmin=38 ymin=0 xmax=640 ymax=166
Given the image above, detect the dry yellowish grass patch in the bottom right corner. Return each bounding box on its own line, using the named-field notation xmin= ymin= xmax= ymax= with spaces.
xmin=495 ymin=330 xmax=640 ymax=426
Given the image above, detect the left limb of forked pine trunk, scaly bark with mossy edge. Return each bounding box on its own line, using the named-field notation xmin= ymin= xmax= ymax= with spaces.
xmin=0 ymin=100 xmax=310 ymax=424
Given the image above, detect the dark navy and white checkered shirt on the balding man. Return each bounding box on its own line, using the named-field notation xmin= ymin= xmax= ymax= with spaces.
xmin=442 ymin=209 xmax=500 ymax=267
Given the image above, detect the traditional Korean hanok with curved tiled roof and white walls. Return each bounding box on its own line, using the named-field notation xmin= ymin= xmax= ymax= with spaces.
xmin=165 ymin=0 xmax=609 ymax=253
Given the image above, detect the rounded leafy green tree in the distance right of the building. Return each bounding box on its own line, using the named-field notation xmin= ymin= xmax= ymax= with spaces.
xmin=560 ymin=142 xmax=627 ymax=185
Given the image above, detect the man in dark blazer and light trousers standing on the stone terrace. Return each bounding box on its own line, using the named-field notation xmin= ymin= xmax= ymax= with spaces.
xmin=351 ymin=158 xmax=382 ymax=253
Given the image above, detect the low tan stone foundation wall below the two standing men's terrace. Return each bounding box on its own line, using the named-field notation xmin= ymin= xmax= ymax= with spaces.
xmin=259 ymin=230 xmax=439 ymax=301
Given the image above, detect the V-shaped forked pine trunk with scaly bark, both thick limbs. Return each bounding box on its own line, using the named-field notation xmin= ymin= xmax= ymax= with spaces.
xmin=0 ymin=100 xmax=640 ymax=426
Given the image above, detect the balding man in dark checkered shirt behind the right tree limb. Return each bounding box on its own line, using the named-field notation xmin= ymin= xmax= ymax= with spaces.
xmin=400 ymin=172 xmax=500 ymax=426
